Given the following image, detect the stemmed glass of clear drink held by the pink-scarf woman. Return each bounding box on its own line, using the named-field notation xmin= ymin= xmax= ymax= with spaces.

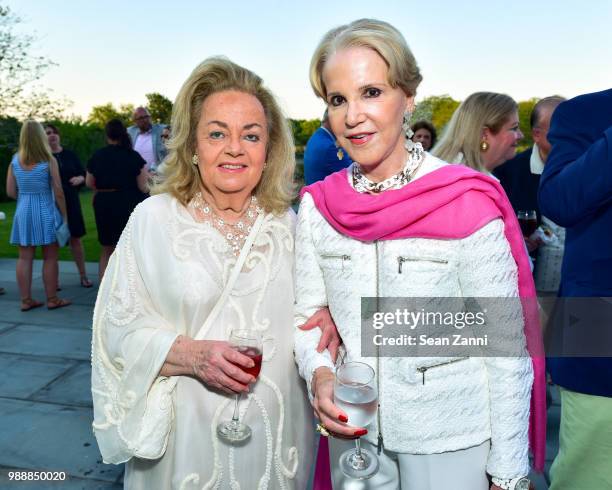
xmin=334 ymin=362 xmax=379 ymax=480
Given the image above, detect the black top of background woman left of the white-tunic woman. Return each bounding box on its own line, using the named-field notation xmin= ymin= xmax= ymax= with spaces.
xmin=87 ymin=145 xmax=146 ymax=191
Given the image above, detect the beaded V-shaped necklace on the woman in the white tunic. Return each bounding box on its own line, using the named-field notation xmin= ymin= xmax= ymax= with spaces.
xmin=187 ymin=192 xmax=263 ymax=256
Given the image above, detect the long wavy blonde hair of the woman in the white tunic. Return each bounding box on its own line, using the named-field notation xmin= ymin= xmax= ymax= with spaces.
xmin=152 ymin=57 xmax=295 ymax=215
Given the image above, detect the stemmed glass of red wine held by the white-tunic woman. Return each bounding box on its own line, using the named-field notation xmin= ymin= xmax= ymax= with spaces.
xmin=217 ymin=329 xmax=263 ymax=444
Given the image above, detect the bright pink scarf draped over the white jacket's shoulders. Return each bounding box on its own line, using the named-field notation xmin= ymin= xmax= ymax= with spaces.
xmin=301 ymin=165 xmax=546 ymax=482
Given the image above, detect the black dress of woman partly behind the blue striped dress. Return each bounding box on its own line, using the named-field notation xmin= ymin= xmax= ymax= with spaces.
xmin=53 ymin=148 xmax=85 ymax=237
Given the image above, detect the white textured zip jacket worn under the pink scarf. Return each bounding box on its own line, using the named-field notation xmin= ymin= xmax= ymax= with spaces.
xmin=295 ymin=154 xmax=533 ymax=478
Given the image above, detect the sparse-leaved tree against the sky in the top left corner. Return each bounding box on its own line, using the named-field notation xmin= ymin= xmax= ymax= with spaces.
xmin=0 ymin=5 xmax=67 ymax=118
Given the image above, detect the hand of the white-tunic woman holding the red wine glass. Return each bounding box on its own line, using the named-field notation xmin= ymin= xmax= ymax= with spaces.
xmin=189 ymin=340 xmax=255 ymax=394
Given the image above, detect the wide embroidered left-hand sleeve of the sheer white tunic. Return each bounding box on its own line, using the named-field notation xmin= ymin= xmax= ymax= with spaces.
xmin=91 ymin=206 xmax=178 ymax=464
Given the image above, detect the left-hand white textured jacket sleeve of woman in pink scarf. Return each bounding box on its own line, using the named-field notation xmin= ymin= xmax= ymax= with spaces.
xmin=294 ymin=193 xmax=334 ymax=400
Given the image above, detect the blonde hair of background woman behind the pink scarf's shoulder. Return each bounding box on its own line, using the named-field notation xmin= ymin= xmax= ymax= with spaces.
xmin=431 ymin=92 xmax=518 ymax=172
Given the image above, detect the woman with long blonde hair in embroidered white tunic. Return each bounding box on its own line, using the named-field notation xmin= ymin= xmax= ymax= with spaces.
xmin=92 ymin=58 xmax=329 ymax=490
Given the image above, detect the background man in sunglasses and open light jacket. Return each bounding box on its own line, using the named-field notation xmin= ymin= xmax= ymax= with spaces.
xmin=127 ymin=107 xmax=166 ymax=172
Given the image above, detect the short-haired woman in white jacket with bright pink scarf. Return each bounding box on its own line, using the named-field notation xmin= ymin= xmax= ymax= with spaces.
xmin=295 ymin=19 xmax=545 ymax=490
